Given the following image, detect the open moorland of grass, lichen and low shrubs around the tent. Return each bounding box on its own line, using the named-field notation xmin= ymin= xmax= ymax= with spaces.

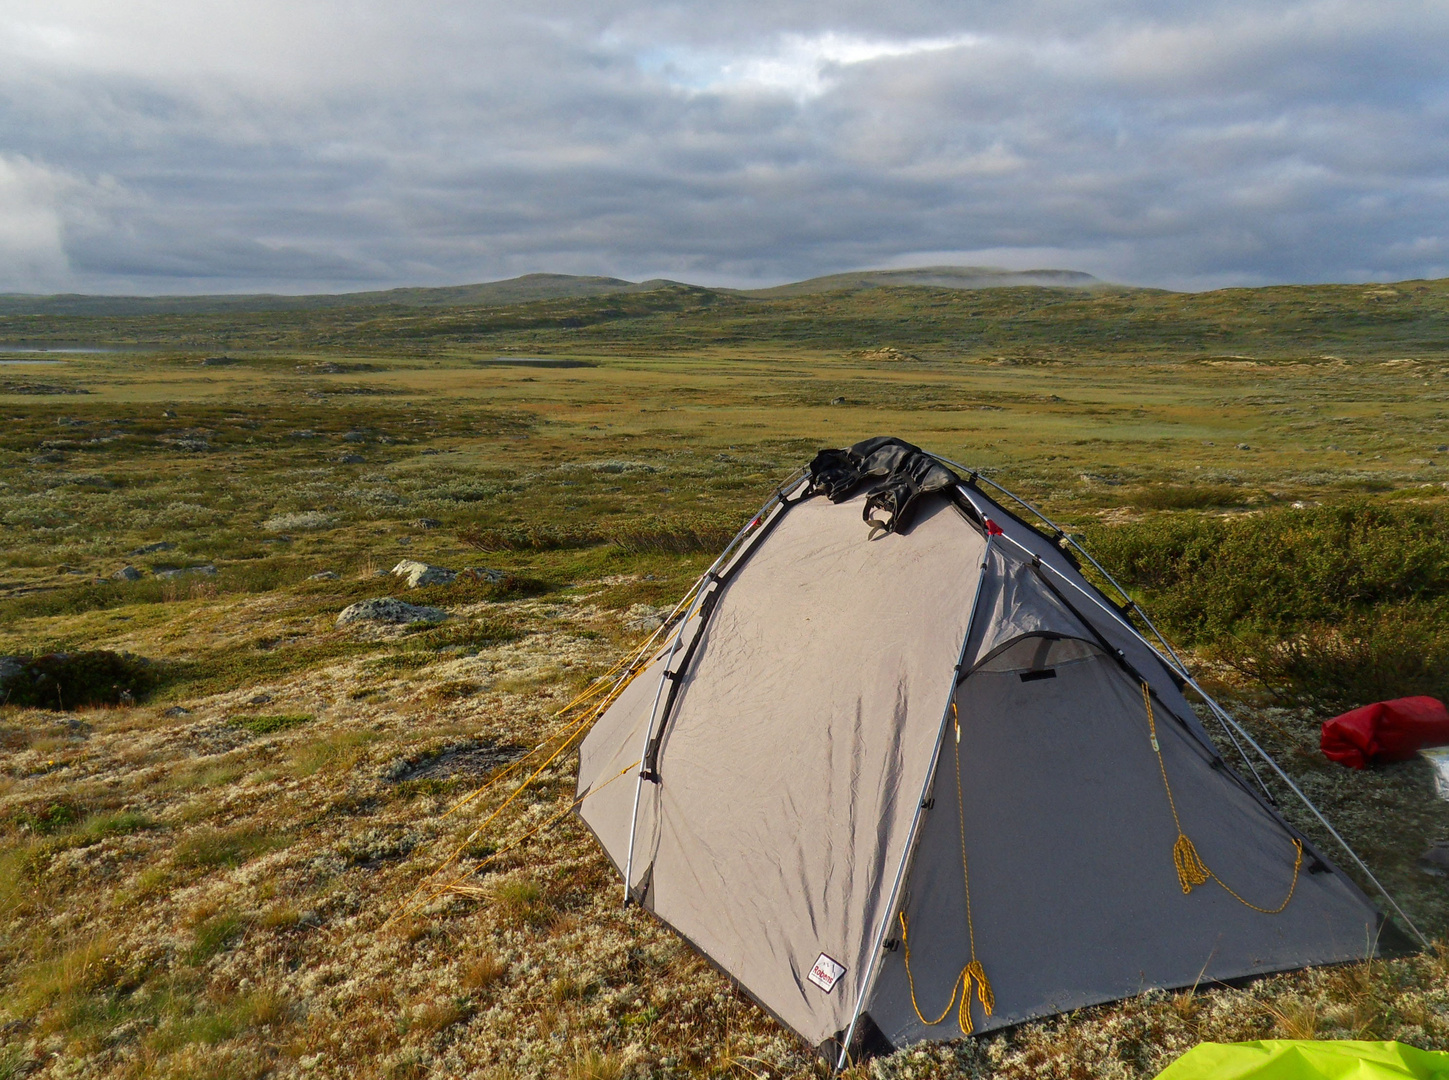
xmin=0 ymin=281 xmax=1449 ymax=1080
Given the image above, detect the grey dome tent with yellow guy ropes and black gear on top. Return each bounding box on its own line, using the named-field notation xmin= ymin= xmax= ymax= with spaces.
xmin=578 ymin=439 xmax=1417 ymax=1067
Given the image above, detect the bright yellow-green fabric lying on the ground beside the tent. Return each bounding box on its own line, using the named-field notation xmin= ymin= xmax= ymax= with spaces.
xmin=1158 ymin=1039 xmax=1449 ymax=1080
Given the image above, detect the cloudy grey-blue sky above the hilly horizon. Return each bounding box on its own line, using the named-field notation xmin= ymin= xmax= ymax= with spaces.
xmin=0 ymin=0 xmax=1449 ymax=294
